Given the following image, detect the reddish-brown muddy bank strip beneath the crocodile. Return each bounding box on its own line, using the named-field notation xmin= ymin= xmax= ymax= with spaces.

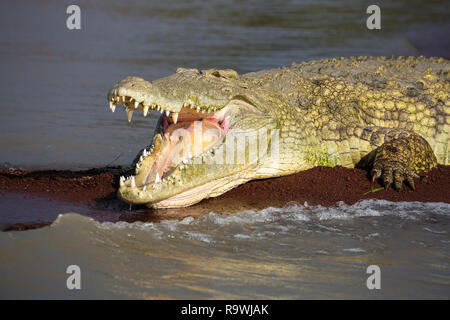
xmin=0 ymin=166 xmax=450 ymax=230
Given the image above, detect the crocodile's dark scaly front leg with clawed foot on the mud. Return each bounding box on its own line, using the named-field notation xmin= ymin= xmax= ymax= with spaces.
xmin=371 ymin=131 xmax=437 ymax=191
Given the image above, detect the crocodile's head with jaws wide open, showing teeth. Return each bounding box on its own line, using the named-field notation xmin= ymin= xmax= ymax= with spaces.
xmin=108 ymin=68 xmax=277 ymax=208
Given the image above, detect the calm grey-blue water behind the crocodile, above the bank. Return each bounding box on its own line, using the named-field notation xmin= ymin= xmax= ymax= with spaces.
xmin=0 ymin=0 xmax=450 ymax=168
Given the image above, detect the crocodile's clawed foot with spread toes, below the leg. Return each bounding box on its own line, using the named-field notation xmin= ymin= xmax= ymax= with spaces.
xmin=371 ymin=161 xmax=419 ymax=191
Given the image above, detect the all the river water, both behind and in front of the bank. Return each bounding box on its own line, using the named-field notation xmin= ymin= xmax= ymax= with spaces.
xmin=0 ymin=0 xmax=450 ymax=299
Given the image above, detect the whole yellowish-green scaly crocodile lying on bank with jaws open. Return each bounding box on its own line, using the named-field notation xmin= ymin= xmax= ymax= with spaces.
xmin=108 ymin=56 xmax=450 ymax=208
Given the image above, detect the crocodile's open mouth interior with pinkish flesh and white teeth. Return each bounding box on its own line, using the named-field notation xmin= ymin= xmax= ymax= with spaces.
xmin=110 ymin=92 xmax=230 ymax=198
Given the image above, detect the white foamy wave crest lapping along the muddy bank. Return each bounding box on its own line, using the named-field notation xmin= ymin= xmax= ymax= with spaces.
xmin=93 ymin=199 xmax=450 ymax=234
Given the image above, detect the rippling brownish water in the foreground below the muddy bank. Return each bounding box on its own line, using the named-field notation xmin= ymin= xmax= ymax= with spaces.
xmin=0 ymin=200 xmax=450 ymax=299
